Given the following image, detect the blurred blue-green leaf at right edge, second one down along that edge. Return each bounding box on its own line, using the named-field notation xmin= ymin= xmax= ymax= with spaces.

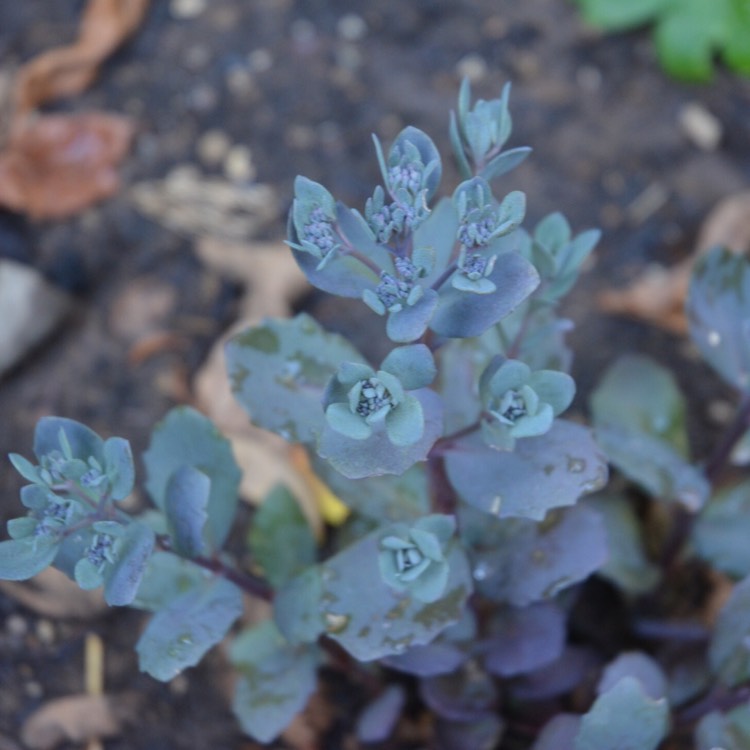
xmin=692 ymin=481 xmax=750 ymax=578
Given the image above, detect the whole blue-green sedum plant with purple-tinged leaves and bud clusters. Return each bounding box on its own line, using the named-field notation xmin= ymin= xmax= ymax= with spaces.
xmin=0 ymin=82 xmax=750 ymax=750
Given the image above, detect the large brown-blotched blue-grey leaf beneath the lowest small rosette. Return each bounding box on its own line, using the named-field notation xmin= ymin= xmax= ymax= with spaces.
xmin=313 ymin=527 xmax=472 ymax=661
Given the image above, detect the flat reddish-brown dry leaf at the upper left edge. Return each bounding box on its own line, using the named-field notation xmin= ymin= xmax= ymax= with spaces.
xmin=0 ymin=113 xmax=134 ymax=219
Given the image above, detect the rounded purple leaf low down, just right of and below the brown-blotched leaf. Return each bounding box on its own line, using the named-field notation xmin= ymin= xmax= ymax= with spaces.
xmin=480 ymin=602 xmax=565 ymax=677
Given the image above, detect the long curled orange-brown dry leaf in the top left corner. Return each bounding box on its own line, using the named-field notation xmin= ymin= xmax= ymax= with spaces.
xmin=15 ymin=0 xmax=149 ymax=117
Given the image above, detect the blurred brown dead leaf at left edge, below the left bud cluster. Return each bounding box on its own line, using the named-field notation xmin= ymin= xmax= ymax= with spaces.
xmin=0 ymin=568 xmax=107 ymax=620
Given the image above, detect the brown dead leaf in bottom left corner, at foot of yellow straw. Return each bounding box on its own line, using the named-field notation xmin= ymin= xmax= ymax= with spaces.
xmin=21 ymin=694 xmax=139 ymax=750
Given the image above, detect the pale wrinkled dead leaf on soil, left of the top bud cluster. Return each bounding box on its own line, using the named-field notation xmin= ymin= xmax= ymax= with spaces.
xmin=131 ymin=166 xmax=280 ymax=241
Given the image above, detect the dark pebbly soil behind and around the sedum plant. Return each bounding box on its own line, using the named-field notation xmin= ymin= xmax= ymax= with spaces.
xmin=0 ymin=0 xmax=750 ymax=750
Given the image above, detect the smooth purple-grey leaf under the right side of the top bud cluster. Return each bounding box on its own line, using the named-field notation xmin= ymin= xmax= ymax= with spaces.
xmin=430 ymin=252 xmax=539 ymax=338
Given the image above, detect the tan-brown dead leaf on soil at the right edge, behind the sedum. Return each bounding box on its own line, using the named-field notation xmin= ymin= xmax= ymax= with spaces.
xmin=597 ymin=191 xmax=750 ymax=334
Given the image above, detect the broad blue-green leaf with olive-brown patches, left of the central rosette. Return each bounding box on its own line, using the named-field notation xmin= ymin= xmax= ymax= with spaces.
xmin=231 ymin=313 xmax=364 ymax=443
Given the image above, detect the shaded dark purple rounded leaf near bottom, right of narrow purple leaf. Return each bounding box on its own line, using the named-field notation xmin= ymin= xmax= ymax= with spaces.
xmin=419 ymin=662 xmax=498 ymax=721
